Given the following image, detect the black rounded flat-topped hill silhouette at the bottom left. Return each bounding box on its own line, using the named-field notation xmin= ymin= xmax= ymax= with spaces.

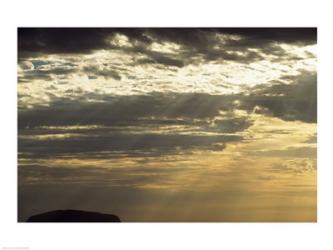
xmin=27 ymin=210 xmax=121 ymax=222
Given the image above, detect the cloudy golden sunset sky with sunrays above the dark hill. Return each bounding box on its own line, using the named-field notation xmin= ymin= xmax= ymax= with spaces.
xmin=17 ymin=28 xmax=317 ymax=222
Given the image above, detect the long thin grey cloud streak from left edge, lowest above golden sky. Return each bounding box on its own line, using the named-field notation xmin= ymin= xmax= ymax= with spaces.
xmin=18 ymin=132 xmax=242 ymax=158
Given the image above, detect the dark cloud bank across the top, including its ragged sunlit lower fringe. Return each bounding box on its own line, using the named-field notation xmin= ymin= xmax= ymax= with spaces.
xmin=18 ymin=28 xmax=317 ymax=67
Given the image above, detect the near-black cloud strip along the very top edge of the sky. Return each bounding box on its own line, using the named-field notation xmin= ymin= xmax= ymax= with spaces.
xmin=18 ymin=28 xmax=317 ymax=53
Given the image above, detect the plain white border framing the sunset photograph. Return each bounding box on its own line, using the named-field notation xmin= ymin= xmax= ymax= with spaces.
xmin=0 ymin=0 xmax=333 ymax=250
